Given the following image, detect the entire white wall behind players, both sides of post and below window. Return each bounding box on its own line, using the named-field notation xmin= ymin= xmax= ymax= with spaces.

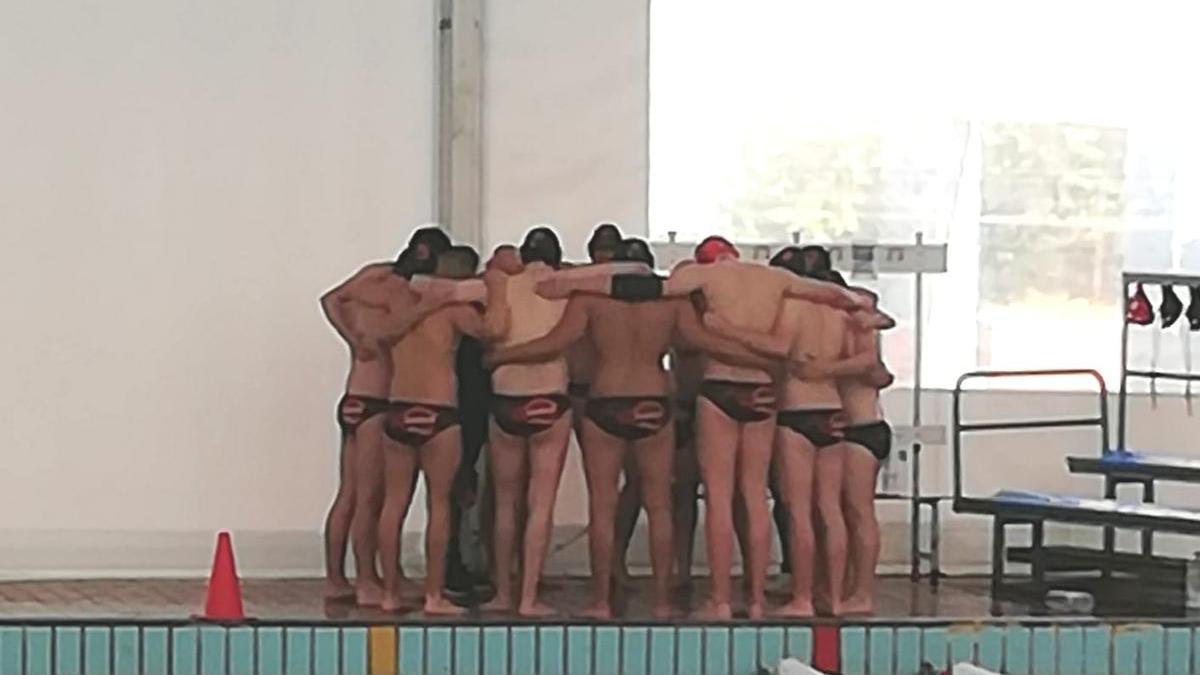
xmin=9 ymin=0 xmax=1200 ymax=575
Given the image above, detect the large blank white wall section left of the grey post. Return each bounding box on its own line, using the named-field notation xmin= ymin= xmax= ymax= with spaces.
xmin=0 ymin=0 xmax=436 ymax=572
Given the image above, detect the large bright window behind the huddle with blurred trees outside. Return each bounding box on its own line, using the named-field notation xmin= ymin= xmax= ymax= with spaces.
xmin=649 ymin=0 xmax=1200 ymax=387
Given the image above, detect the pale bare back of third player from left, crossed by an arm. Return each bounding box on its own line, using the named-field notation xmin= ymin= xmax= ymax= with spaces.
xmin=492 ymin=263 xmax=566 ymax=396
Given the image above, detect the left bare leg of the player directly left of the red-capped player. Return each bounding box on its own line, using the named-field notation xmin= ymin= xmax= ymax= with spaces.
xmin=582 ymin=419 xmax=626 ymax=620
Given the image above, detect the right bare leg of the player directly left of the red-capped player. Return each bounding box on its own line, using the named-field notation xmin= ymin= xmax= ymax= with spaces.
xmin=634 ymin=425 xmax=674 ymax=619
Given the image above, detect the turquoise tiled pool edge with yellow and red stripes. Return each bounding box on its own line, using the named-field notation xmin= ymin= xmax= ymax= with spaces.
xmin=0 ymin=619 xmax=1185 ymax=675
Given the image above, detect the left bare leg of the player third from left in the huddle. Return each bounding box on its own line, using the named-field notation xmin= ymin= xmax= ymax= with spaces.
xmin=482 ymin=420 xmax=526 ymax=611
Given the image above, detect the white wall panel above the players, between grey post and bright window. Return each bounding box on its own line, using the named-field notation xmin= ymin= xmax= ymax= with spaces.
xmin=484 ymin=0 xmax=649 ymax=258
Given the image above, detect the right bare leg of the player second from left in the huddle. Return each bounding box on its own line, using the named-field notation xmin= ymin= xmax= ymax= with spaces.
xmin=420 ymin=426 xmax=466 ymax=615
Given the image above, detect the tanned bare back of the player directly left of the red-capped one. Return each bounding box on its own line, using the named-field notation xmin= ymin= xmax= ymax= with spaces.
xmin=587 ymin=297 xmax=682 ymax=396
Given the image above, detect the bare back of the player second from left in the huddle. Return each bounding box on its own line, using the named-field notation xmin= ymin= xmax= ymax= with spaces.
xmin=389 ymin=305 xmax=475 ymax=405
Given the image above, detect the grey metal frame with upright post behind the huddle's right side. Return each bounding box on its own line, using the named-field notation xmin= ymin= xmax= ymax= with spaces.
xmin=652 ymin=232 xmax=952 ymax=578
